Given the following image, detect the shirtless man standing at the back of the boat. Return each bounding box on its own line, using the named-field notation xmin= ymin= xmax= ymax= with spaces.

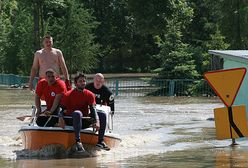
xmin=29 ymin=35 xmax=71 ymax=91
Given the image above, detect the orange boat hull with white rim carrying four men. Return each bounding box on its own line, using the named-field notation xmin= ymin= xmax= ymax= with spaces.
xmin=19 ymin=126 xmax=121 ymax=150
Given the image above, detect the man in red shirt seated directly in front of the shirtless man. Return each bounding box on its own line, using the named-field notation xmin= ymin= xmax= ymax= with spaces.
xmin=35 ymin=69 xmax=66 ymax=126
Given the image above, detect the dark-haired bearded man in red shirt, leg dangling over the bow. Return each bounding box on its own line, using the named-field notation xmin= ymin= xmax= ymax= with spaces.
xmin=59 ymin=74 xmax=101 ymax=152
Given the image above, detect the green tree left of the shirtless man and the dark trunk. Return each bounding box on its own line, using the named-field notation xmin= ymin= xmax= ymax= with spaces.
xmin=6 ymin=6 xmax=33 ymax=74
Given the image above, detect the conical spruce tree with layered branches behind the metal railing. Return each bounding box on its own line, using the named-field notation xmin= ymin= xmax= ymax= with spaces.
xmin=159 ymin=21 xmax=199 ymax=79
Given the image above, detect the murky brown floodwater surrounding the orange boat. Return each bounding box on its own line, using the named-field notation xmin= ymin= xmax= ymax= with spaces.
xmin=0 ymin=88 xmax=248 ymax=168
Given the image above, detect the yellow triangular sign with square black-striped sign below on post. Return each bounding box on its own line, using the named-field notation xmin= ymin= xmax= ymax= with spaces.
xmin=204 ymin=68 xmax=248 ymax=145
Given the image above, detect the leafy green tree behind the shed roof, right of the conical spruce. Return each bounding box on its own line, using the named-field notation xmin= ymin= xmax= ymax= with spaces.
xmin=179 ymin=0 xmax=230 ymax=74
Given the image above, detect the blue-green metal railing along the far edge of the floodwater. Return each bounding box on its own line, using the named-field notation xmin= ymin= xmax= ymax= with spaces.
xmin=0 ymin=74 xmax=215 ymax=96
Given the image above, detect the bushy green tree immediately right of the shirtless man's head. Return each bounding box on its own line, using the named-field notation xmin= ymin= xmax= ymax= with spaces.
xmin=61 ymin=1 xmax=99 ymax=73
